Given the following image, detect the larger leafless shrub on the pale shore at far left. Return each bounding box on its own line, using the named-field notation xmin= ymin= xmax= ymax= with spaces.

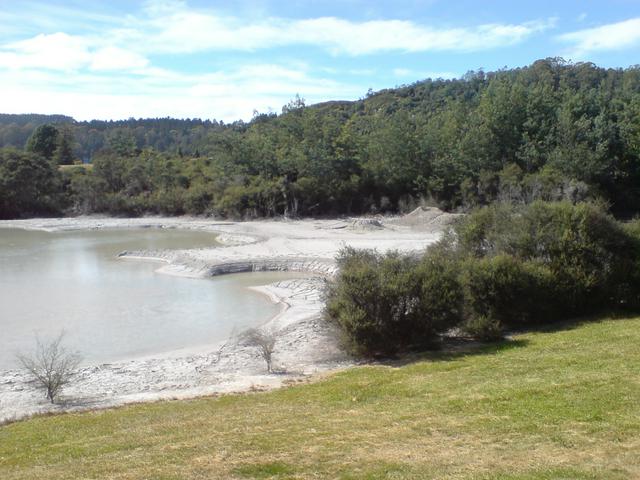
xmin=17 ymin=332 xmax=81 ymax=403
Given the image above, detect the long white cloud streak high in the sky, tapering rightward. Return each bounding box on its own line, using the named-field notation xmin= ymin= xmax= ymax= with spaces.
xmin=130 ymin=4 xmax=555 ymax=56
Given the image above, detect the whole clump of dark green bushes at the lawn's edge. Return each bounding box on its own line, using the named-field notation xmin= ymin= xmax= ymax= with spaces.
xmin=326 ymin=202 xmax=640 ymax=355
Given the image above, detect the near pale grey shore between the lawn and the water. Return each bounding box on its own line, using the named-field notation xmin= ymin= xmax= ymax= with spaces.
xmin=0 ymin=279 xmax=344 ymax=424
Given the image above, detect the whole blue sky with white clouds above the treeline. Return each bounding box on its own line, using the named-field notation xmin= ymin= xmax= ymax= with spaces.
xmin=0 ymin=0 xmax=640 ymax=121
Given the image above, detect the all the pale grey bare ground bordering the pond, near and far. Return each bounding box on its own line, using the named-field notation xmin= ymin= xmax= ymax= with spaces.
xmin=0 ymin=209 xmax=456 ymax=421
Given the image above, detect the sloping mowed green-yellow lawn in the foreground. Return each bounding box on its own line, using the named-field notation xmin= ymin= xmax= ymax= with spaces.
xmin=0 ymin=318 xmax=640 ymax=480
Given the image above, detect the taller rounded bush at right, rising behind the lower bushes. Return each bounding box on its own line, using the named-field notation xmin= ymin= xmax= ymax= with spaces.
xmin=453 ymin=202 xmax=633 ymax=316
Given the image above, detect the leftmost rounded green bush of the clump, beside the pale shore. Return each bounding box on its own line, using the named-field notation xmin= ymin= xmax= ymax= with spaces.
xmin=326 ymin=248 xmax=462 ymax=356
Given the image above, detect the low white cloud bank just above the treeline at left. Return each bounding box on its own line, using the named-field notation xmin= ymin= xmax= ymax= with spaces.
xmin=0 ymin=64 xmax=363 ymax=121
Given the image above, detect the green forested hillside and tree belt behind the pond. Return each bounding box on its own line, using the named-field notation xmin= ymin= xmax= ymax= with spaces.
xmin=0 ymin=59 xmax=640 ymax=217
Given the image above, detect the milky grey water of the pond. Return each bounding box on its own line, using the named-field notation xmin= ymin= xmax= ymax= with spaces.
xmin=0 ymin=228 xmax=291 ymax=369
